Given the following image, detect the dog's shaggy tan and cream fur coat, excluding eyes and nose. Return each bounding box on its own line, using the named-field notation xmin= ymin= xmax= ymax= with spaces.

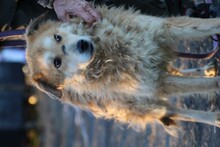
xmin=26 ymin=6 xmax=220 ymax=135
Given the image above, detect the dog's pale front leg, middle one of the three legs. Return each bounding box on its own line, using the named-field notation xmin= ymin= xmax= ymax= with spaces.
xmin=161 ymin=76 xmax=220 ymax=96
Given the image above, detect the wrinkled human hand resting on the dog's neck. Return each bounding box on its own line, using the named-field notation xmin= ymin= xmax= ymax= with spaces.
xmin=53 ymin=0 xmax=101 ymax=24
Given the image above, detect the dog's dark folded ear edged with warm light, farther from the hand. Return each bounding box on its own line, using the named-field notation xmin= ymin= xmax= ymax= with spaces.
xmin=34 ymin=76 xmax=63 ymax=99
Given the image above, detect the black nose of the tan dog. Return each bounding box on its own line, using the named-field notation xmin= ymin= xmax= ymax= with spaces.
xmin=77 ymin=39 xmax=93 ymax=53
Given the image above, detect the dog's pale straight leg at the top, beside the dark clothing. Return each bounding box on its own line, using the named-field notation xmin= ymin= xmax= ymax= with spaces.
xmin=164 ymin=17 xmax=220 ymax=40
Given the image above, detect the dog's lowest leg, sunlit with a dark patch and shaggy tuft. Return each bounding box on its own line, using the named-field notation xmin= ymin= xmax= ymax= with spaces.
xmin=139 ymin=100 xmax=220 ymax=136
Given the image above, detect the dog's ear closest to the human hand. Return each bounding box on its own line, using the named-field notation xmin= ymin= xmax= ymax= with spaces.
xmin=26 ymin=11 xmax=49 ymax=36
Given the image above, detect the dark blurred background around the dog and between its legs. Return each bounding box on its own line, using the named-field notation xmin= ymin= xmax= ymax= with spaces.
xmin=0 ymin=0 xmax=220 ymax=147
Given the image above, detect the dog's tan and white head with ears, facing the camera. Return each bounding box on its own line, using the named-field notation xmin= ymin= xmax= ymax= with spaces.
xmin=26 ymin=14 xmax=95 ymax=98
